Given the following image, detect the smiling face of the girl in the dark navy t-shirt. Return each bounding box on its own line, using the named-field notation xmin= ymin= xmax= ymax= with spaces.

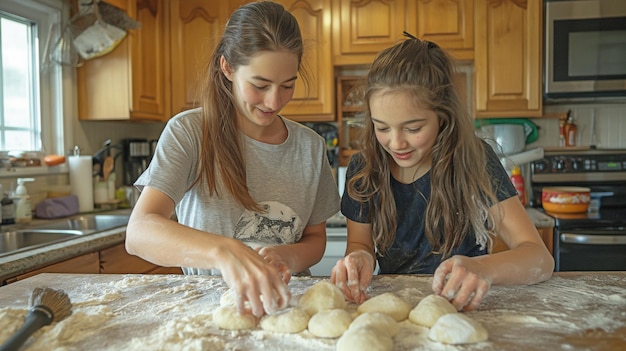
xmin=369 ymin=90 xmax=439 ymax=182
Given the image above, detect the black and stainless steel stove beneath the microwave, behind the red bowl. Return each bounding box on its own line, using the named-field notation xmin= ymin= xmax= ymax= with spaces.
xmin=530 ymin=149 xmax=626 ymax=271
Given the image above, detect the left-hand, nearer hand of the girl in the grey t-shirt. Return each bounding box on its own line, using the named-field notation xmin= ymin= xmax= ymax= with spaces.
xmin=218 ymin=240 xmax=291 ymax=317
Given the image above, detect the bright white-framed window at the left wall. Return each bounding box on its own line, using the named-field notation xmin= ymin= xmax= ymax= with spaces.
xmin=0 ymin=0 xmax=69 ymax=159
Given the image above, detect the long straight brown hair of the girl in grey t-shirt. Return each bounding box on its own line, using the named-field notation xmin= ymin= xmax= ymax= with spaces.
xmin=192 ymin=1 xmax=306 ymax=211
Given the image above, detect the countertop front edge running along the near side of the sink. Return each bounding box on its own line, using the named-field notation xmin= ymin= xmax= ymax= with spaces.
xmin=0 ymin=226 xmax=126 ymax=284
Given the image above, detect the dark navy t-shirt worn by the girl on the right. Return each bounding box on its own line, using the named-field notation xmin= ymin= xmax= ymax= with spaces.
xmin=341 ymin=147 xmax=517 ymax=274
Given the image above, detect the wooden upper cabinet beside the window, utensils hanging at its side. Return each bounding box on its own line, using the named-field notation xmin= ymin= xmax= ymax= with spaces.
xmin=77 ymin=0 xmax=170 ymax=121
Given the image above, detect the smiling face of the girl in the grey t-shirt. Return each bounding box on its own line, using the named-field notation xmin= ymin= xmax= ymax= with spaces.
xmin=221 ymin=51 xmax=298 ymax=128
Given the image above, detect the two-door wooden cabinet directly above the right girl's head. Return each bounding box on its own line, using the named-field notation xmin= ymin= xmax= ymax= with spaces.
xmin=333 ymin=0 xmax=474 ymax=65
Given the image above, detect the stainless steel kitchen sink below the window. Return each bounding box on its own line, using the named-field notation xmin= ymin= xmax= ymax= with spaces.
xmin=0 ymin=214 xmax=130 ymax=257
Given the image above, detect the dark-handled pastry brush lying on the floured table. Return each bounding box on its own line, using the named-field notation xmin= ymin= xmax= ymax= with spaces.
xmin=0 ymin=287 xmax=72 ymax=351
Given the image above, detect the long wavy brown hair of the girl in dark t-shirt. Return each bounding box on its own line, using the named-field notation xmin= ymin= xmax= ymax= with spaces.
xmin=347 ymin=38 xmax=497 ymax=258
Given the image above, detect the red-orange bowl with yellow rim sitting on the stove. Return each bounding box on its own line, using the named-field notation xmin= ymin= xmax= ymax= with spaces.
xmin=541 ymin=186 xmax=591 ymax=213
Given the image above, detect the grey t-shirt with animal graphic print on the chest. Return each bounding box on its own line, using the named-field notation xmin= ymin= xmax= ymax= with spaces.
xmin=135 ymin=109 xmax=340 ymax=274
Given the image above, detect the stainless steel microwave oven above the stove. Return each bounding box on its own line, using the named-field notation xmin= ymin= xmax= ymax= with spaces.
xmin=543 ymin=0 xmax=626 ymax=100
